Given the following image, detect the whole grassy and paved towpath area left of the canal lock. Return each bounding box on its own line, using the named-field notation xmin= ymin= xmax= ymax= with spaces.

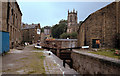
xmin=2 ymin=45 xmax=78 ymax=74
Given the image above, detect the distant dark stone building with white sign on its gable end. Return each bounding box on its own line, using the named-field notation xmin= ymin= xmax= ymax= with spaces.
xmin=21 ymin=24 xmax=41 ymax=44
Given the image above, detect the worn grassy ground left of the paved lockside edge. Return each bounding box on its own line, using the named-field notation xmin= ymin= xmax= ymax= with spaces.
xmin=2 ymin=52 xmax=45 ymax=74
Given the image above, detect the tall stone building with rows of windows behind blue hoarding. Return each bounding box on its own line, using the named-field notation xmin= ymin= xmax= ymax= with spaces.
xmin=0 ymin=0 xmax=22 ymax=48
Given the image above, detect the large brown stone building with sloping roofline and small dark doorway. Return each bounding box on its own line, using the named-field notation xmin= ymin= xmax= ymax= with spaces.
xmin=78 ymin=2 xmax=120 ymax=48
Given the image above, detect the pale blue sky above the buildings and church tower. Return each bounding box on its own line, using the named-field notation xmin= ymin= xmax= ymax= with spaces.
xmin=18 ymin=2 xmax=110 ymax=27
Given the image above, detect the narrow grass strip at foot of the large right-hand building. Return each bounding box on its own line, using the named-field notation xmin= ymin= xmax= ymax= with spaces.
xmin=88 ymin=51 xmax=120 ymax=59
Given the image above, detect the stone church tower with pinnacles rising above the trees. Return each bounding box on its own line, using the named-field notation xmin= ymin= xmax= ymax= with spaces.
xmin=67 ymin=9 xmax=77 ymax=33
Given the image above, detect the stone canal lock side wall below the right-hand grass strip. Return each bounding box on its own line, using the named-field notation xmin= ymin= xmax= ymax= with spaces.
xmin=71 ymin=50 xmax=120 ymax=75
